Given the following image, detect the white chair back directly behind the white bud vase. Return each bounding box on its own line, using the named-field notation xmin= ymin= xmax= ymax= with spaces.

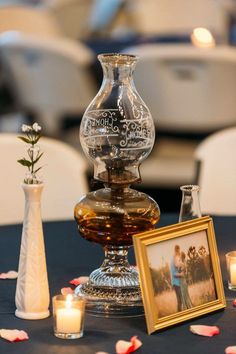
xmin=0 ymin=133 xmax=88 ymax=225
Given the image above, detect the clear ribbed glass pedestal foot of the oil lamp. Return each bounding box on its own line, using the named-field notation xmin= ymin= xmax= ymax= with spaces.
xmin=75 ymin=246 xmax=144 ymax=317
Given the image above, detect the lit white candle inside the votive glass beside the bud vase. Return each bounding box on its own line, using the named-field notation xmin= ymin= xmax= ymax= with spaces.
xmin=56 ymin=295 xmax=82 ymax=333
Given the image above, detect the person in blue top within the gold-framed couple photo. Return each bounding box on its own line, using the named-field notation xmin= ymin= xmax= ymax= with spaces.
xmin=170 ymin=245 xmax=182 ymax=312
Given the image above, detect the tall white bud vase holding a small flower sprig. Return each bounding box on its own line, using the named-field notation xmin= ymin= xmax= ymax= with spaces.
xmin=15 ymin=184 xmax=50 ymax=320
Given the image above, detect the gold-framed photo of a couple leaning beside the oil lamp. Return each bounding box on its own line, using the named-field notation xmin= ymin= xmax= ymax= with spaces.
xmin=133 ymin=216 xmax=226 ymax=334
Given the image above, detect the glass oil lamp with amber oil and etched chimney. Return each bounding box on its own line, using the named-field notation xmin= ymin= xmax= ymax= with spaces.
xmin=75 ymin=54 xmax=160 ymax=316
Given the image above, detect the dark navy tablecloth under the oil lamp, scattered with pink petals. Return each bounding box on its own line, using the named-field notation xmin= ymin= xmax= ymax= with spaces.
xmin=0 ymin=215 xmax=236 ymax=354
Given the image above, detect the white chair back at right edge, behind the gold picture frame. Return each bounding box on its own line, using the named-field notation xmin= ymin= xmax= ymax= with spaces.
xmin=195 ymin=127 xmax=236 ymax=215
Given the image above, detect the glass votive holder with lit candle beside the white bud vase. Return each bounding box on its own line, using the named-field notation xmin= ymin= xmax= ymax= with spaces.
xmin=52 ymin=294 xmax=85 ymax=339
